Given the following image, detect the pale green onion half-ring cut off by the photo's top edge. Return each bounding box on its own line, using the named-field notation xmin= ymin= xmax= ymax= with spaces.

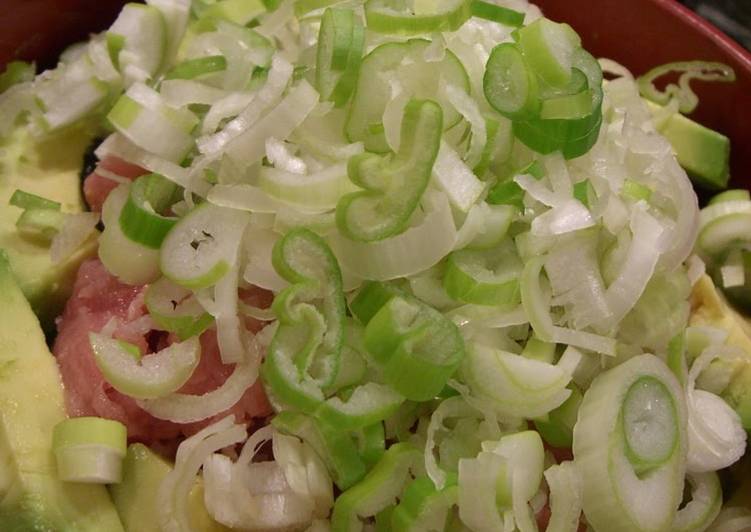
xmin=365 ymin=0 xmax=471 ymax=35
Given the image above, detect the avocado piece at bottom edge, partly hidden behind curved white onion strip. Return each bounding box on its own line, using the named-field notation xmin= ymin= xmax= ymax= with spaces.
xmin=109 ymin=443 xmax=229 ymax=532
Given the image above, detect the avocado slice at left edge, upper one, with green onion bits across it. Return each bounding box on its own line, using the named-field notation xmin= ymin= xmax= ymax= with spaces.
xmin=0 ymin=126 xmax=96 ymax=330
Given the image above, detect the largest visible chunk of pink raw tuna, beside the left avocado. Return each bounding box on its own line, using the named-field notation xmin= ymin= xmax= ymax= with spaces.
xmin=53 ymin=259 xmax=271 ymax=450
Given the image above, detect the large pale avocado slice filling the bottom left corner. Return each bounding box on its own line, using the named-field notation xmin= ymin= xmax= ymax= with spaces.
xmin=0 ymin=251 xmax=123 ymax=532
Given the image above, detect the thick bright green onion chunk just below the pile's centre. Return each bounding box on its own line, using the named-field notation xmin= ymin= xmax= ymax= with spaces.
xmin=365 ymin=288 xmax=464 ymax=401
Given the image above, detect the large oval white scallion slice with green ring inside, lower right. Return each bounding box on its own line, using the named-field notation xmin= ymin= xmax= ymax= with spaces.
xmin=573 ymin=355 xmax=688 ymax=532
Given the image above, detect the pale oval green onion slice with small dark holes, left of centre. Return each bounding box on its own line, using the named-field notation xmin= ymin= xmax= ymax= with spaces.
xmin=159 ymin=203 xmax=250 ymax=290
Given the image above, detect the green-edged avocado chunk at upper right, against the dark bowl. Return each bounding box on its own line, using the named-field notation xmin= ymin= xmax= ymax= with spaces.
xmin=645 ymin=100 xmax=730 ymax=189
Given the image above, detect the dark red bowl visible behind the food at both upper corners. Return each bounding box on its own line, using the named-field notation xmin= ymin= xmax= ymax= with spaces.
xmin=0 ymin=0 xmax=751 ymax=186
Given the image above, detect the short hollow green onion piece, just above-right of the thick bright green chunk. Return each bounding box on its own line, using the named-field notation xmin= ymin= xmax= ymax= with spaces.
xmin=443 ymin=240 xmax=522 ymax=306
